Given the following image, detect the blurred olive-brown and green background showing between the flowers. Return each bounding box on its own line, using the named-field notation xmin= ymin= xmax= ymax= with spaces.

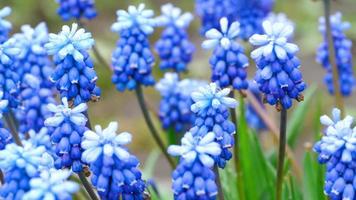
xmin=0 ymin=0 xmax=356 ymax=195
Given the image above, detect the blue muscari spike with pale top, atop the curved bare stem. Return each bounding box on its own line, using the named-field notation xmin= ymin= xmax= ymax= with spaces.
xmin=111 ymin=4 xmax=155 ymax=91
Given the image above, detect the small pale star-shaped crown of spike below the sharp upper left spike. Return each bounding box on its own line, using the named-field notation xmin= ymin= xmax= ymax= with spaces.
xmin=45 ymin=97 xmax=88 ymax=127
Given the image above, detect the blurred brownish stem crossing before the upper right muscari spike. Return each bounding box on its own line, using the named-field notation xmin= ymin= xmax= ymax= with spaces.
xmin=324 ymin=0 xmax=345 ymax=115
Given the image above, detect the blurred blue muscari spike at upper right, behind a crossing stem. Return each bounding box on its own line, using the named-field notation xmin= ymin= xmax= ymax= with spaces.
xmin=316 ymin=12 xmax=355 ymax=96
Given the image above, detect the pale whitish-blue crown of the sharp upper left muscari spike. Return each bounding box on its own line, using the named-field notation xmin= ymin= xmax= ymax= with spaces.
xmin=45 ymin=23 xmax=94 ymax=62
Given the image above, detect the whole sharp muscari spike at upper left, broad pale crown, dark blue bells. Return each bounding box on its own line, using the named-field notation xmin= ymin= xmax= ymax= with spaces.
xmin=45 ymin=24 xmax=100 ymax=105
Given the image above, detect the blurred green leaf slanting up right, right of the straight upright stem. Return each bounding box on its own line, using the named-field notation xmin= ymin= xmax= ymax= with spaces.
xmin=287 ymin=86 xmax=317 ymax=148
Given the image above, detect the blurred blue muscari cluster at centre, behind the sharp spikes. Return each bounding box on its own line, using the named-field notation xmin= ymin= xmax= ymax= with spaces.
xmin=156 ymin=72 xmax=204 ymax=132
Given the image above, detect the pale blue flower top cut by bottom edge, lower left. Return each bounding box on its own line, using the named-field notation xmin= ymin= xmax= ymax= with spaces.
xmin=23 ymin=169 xmax=80 ymax=200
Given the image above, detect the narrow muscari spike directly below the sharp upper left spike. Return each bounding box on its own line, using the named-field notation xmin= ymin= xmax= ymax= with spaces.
xmin=44 ymin=97 xmax=88 ymax=172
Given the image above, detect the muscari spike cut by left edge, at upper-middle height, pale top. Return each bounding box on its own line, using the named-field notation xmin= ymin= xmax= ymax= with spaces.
xmin=0 ymin=38 xmax=21 ymax=107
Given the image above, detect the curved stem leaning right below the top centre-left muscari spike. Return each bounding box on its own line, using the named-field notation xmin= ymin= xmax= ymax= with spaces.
xmin=136 ymin=85 xmax=175 ymax=169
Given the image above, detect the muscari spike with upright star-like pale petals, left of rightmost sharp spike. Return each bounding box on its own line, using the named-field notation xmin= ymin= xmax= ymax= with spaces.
xmin=202 ymin=18 xmax=248 ymax=90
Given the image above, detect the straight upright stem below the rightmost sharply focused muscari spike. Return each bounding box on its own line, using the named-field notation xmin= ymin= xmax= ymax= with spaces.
xmin=276 ymin=108 xmax=287 ymax=200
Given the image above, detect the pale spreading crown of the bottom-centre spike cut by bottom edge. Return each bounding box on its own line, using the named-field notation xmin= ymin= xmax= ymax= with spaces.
xmin=168 ymin=132 xmax=221 ymax=167
